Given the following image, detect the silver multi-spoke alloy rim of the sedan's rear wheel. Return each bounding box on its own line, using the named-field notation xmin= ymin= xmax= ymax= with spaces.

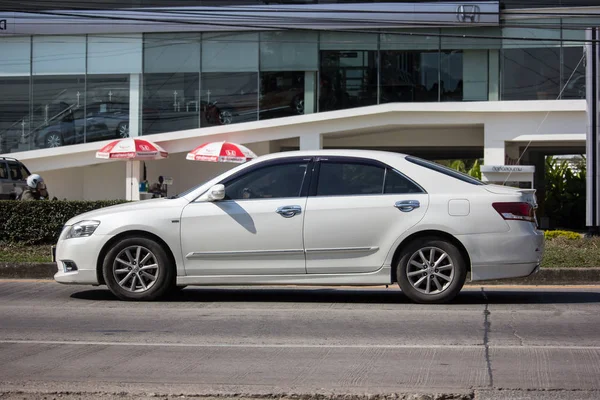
xmin=406 ymin=247 xmax=455 ymax=295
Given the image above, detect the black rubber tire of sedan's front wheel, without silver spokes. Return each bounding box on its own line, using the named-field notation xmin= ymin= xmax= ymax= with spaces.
xmin=102 ymin=237 xmax=175 ymax=301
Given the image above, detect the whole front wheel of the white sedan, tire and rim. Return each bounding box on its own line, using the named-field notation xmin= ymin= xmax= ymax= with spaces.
xmin=102 ymin=238 xmax=174 ymax=300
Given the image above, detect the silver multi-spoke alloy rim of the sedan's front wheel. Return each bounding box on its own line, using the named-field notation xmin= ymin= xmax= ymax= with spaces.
xmin=113 ymin=246 xmax=159 ymax=293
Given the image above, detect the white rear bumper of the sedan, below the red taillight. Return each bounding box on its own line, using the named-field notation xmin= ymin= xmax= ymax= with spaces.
xmin=458 ymin=222 xmax=544 ymax=281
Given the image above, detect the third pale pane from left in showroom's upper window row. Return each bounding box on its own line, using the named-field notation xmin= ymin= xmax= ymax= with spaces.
xmin=88 ymin=34 xmax=142 ymax=74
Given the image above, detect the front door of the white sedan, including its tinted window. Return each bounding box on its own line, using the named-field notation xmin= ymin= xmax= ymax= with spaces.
xmin=181 ymin=158 xmax=311 ymax=276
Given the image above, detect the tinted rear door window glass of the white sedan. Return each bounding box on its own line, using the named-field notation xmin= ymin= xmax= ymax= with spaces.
xmin=317 ymin=161 xmax=423 ymax=196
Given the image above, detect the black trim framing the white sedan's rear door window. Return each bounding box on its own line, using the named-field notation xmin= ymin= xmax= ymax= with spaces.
xmin=308 ymin=156 xmax=427 ymax=197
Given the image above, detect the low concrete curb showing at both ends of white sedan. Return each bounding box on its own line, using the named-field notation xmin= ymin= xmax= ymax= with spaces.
xmin=0 ymin=262 xmax=600 ymax=285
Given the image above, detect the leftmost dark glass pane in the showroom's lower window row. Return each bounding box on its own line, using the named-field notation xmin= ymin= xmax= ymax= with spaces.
xmin=0 ymin=77 xmax=30 ymax=154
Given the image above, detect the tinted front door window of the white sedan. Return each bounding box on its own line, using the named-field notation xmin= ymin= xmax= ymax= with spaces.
xmin=225 ymin=161 xmax=308 ymax=200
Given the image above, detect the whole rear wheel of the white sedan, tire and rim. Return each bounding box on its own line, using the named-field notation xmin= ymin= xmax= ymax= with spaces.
xmin=396 ymin=237 xmax=467 ymax=304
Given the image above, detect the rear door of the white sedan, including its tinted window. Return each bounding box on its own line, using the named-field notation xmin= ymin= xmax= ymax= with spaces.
xmin=304 ymin=157 xmax=429 ymax=274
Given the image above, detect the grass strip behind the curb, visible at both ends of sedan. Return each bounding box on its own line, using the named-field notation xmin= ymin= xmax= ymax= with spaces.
xmin=0 ymin=237 xmax=600 ymax=268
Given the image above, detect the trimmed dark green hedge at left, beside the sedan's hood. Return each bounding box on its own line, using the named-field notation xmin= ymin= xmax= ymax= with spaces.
xmin=0 ymin=200 xmax=125 ymax=244
